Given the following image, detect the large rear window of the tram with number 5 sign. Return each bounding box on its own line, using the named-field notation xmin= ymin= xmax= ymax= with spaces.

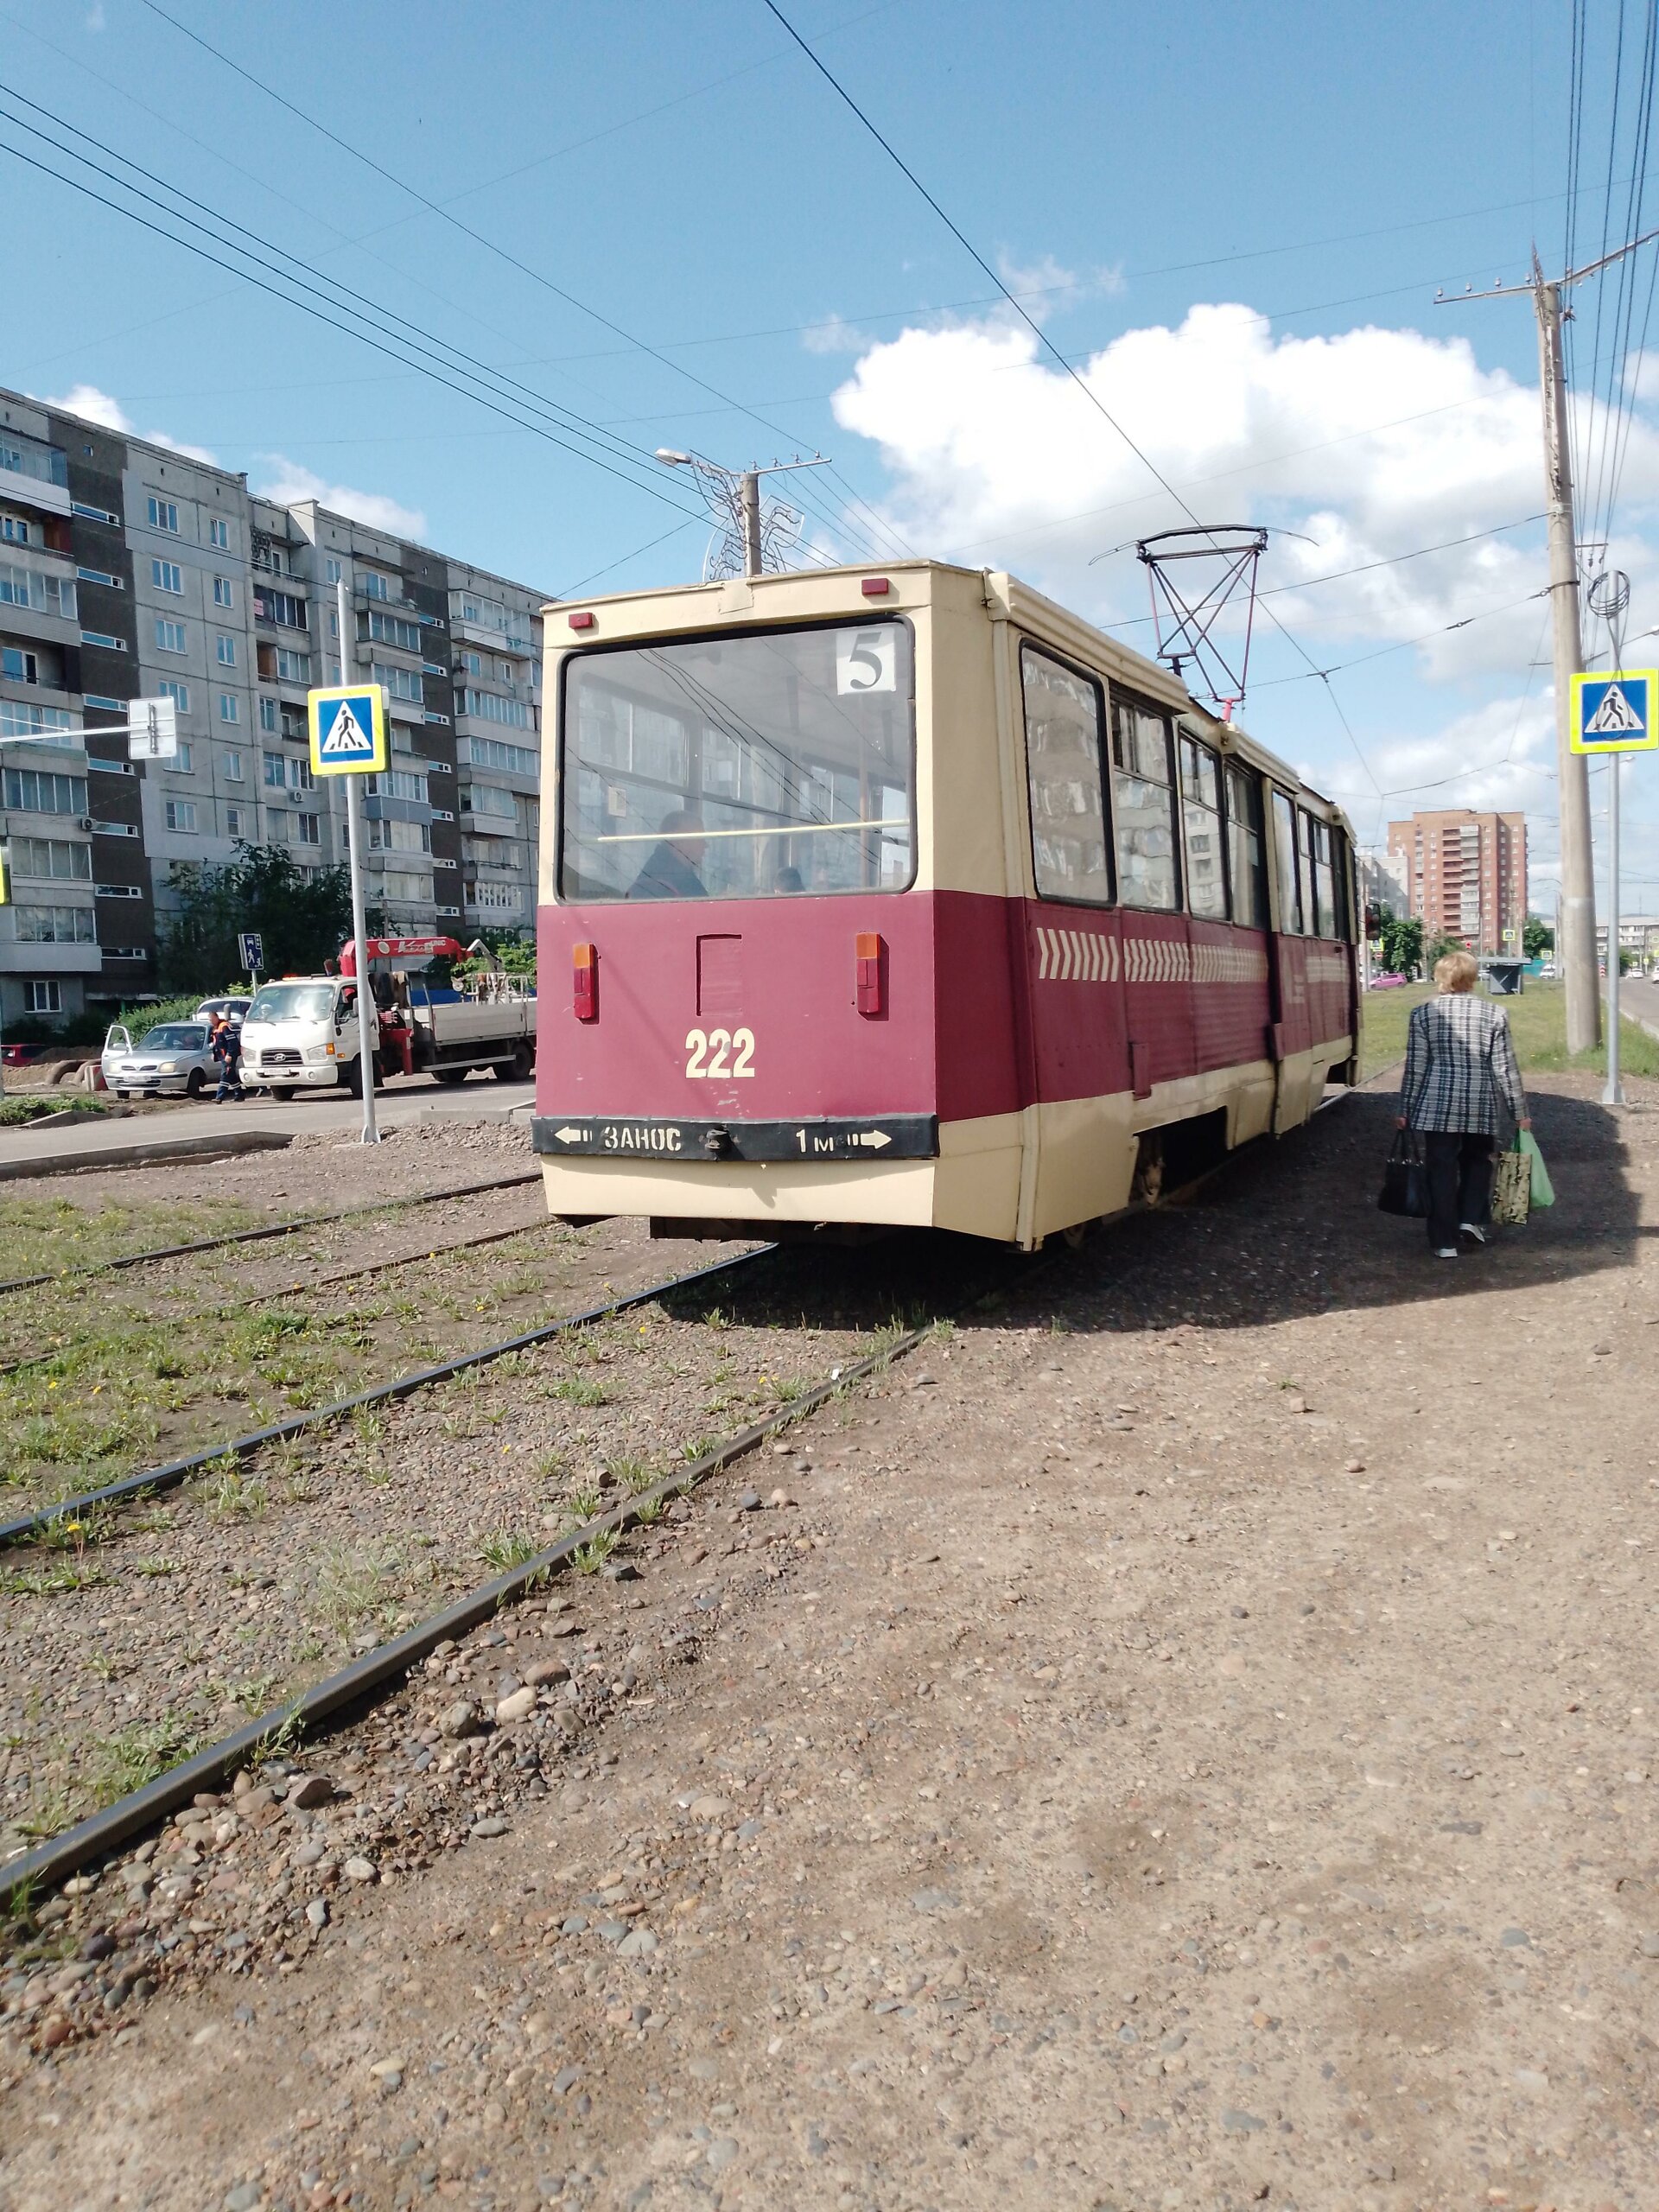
xmin=560 ymin=621 xmax=916 ymax=900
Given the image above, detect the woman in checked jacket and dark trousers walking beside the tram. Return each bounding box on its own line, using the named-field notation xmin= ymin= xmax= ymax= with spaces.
xmin=1400 ymin=953 xmax=1533 ymax=1259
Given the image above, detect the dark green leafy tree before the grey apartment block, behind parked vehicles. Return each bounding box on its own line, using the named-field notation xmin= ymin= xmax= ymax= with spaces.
xmin=159 ymin=845 xmax=365 ymax=991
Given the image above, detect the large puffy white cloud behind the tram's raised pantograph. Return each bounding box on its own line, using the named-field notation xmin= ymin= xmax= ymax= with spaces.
xmin=834 ymin=305 xmax=1659 ymax=679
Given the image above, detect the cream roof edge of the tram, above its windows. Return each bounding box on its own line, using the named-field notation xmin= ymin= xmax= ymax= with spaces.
xmin=553 ymin=556 xmax=1351 ymax=836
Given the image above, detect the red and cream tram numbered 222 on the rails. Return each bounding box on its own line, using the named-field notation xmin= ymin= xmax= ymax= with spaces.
xmin=536 ymin=560 xmax=1358 ymax=1248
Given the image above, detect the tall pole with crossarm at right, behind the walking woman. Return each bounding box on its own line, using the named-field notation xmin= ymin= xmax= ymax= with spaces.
xmin=1435 ymin=230 xmax=1659 ymax=1053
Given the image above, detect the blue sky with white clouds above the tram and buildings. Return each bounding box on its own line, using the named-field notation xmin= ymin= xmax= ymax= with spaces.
xmin=0 ymin=0 xmax=1659 ymax=913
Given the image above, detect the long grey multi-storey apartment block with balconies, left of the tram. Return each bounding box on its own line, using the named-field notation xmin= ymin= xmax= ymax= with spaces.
xmin=0 ymin=391 xmax=559 ymax=1020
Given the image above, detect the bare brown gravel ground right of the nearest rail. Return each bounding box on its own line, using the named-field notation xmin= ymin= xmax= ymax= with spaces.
xmin=0 ymin=1077 xmax=1659 ymax=2212
